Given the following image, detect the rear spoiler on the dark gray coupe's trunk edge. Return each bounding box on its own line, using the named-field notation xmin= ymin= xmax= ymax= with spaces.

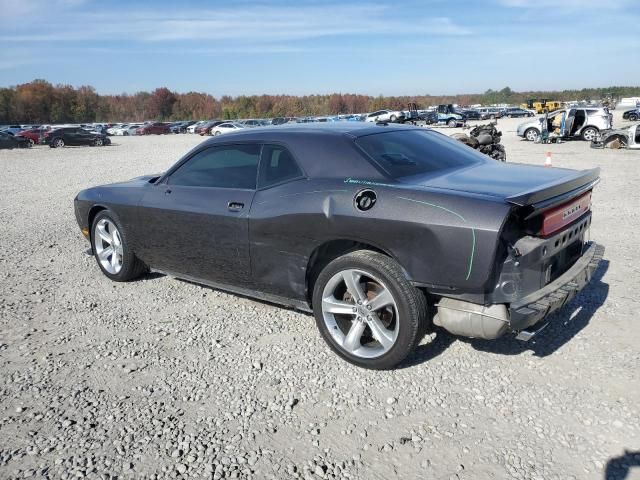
xmin=506 ymin=168 xmax=600 ymax=208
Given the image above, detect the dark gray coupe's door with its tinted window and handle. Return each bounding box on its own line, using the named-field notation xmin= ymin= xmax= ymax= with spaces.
xmin=135 ymin=143 xmax=261 ymax=286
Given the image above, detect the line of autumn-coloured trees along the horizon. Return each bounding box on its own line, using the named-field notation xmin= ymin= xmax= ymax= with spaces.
xmin=0 ymin=79 xmax=640 ymax=124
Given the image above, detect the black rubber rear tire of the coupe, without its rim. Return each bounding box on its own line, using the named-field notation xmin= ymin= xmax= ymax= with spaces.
xmin=313 ymin=250 xmax=428 ymax=370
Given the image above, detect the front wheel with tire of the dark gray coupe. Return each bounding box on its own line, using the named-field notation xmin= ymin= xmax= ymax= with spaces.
xmin=91 ymin=210 xmax=146 ymax=282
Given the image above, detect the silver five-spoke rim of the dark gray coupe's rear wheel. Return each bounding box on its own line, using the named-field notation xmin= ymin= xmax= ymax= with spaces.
xmin=322 ymin=269 xmax=399 ymax=358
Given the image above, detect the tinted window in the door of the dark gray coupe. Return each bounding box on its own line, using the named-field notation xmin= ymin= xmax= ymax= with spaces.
xmin=168 ymin=144 xmax=260 ymax=189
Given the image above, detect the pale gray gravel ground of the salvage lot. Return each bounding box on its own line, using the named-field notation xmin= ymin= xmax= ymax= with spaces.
xmin=0 ymin=113 xmax=640 ymax=479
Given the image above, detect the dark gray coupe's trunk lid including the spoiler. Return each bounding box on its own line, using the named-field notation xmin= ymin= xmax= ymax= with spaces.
xmin=403 ymin=161 xmax=599 ymax=205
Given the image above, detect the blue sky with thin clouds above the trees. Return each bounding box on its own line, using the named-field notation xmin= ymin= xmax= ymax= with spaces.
xmin=0 ymin=0 xmax=640 ymax=96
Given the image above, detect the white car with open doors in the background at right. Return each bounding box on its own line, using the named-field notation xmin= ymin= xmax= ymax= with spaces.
xmin=516 ymin=107 xmax=613 ymax=142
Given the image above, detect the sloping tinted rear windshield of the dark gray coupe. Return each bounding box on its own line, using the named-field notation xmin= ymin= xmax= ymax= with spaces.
xmin=356 ymin=130 xmax=485 ymax=179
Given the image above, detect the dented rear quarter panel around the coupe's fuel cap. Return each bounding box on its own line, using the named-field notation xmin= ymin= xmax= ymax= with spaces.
xmin=249 ymin=178 xmax=510 ymax=299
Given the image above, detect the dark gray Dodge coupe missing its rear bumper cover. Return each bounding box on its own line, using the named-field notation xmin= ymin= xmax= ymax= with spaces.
xmin=75 ymin=122 xmax=603 ymax=369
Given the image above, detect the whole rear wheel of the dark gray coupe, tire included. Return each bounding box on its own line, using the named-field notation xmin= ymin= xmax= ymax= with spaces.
xmin=313 ymin=250 xmax=427 ymax=370
